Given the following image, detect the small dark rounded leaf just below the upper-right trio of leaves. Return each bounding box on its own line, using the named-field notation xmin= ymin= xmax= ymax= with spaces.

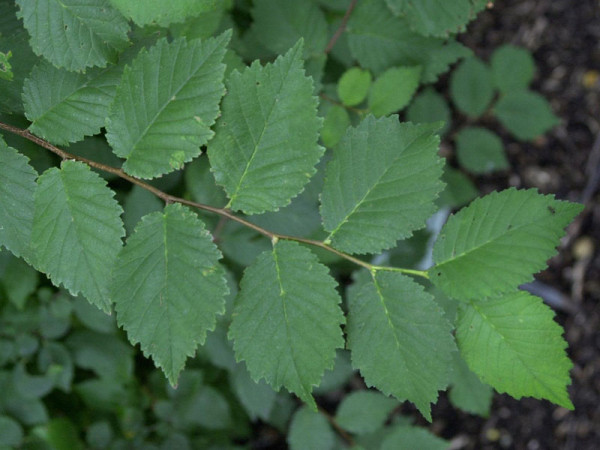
xmin=455 ymin=127 xmax=510 ymax=174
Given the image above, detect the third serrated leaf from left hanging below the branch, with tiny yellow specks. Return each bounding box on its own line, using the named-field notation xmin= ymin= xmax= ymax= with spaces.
xmin=111 ymin=204 xmax=228 ymax=386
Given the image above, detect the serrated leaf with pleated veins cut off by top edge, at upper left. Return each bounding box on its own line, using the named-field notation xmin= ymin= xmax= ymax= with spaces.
xmin=16 ymin=0 xmax=129 ymax=71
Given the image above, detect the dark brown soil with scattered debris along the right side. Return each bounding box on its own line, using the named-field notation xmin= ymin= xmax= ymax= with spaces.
xmin=432 ymin=0 xmax=600 ymax=450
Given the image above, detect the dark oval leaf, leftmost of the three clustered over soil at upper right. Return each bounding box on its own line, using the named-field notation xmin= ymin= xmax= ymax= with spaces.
xmin=450 ymin=57 xmax=494 ymax=118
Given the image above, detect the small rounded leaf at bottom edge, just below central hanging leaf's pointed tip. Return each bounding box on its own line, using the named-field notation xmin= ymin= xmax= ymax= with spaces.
xmin=287 ymin=407 xmax=335 ymax=450
